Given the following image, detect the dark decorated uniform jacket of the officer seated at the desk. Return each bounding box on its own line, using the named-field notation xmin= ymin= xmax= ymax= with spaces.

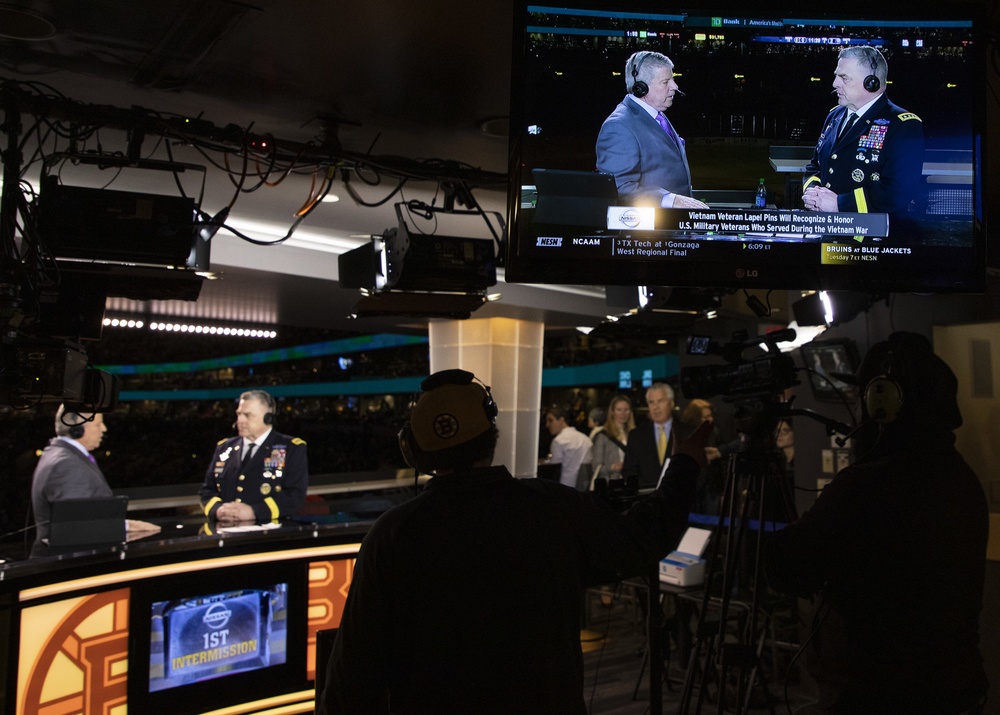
xmin=200 ymin=431 xmax=309 ymax=524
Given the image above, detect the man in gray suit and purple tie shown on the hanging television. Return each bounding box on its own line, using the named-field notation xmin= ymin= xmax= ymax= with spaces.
xmin=597 ymin=51 xmax=708 ymax=209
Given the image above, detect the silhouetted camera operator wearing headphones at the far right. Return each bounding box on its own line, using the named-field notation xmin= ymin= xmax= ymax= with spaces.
xmin=763 ymin=333 xmax=989 ymax=715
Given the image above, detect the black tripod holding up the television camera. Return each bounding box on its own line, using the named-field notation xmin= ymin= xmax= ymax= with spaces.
xmin=679 ymin=403 xmax=794 ymax=715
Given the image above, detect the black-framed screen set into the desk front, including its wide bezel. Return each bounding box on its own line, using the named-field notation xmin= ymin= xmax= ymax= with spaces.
xmin=128 ymin=562 xmax=308 ymax=715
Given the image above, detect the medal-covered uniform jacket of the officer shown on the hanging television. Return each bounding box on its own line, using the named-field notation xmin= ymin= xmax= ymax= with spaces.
xmin=802 ymin=95 xmax=924 ymax=222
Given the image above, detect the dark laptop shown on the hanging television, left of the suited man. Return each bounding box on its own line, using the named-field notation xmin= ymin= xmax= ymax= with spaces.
xmin=531 ymin=169 xmax=618 ymax=229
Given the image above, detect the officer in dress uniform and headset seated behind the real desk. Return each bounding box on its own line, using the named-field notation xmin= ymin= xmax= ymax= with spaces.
xmin=200 ymin=390 xmax=309 ymax=524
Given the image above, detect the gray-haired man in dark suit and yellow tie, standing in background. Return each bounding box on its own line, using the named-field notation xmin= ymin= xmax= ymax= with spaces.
xmin=622 ymin=382 xmax=675 ymax=489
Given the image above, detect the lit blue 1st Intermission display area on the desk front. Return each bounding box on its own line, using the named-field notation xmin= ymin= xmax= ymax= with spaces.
xmin=149 ymin=583 xmax=288 ymax=692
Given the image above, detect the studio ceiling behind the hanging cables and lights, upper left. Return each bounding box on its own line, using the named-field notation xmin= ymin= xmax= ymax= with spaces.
xmin=0 ymin=0 xmax=620 ymax=331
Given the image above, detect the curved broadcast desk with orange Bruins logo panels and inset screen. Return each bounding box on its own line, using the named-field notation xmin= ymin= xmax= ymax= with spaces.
xmin=0 ymin=515 xmax=371 ymax=715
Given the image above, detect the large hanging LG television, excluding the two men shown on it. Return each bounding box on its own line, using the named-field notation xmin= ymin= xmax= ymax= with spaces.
xmin=505 ymin=0 xmax=987 ymax=293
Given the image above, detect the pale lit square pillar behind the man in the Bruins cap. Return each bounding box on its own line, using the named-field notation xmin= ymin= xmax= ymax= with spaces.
xmin=428 ymin=318 xmax=545 ymax=477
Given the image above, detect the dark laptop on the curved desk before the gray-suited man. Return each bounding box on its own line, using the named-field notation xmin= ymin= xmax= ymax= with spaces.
xmin=49 ymin=496 xmax=128 ymax=548
